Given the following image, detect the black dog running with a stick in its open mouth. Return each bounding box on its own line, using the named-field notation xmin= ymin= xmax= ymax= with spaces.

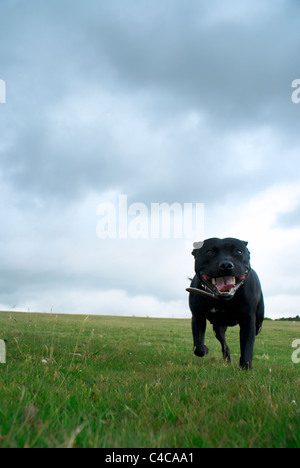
xmin=187 ymin=237 xmax=264 ymax=369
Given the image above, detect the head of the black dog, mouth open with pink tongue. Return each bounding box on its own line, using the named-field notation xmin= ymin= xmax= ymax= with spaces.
xmin=192 ymin=237 xmax=251 ymax=294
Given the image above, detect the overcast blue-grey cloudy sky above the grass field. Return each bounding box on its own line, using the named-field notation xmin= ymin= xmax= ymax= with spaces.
xmin=0 ymin=0 xmax=300 ymax=318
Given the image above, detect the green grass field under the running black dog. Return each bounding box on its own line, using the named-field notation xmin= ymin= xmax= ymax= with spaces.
xmin=0 ymin=312 xmax=300 ymax=448
